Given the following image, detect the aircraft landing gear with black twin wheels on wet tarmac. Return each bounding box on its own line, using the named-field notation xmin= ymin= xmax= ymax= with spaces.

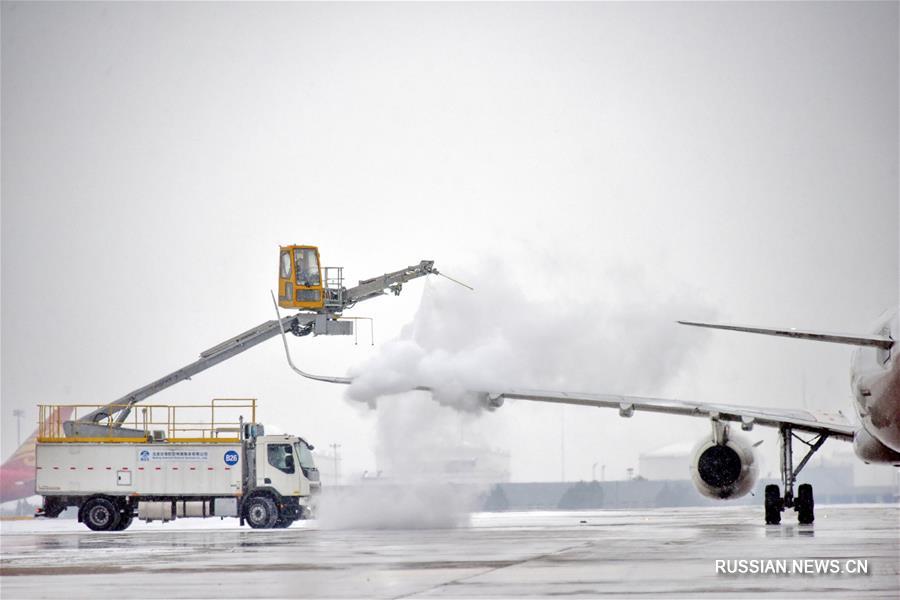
xmin=766 ymin=425 xmax=828 ymax=525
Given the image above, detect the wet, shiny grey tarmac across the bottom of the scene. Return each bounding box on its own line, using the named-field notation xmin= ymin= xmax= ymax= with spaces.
xmin=0 ymin=505 xmax=900 ymax=600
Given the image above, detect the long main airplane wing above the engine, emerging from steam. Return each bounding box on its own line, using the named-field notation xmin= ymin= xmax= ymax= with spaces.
xmin=487 ymin=390 xmax=857 ymax=441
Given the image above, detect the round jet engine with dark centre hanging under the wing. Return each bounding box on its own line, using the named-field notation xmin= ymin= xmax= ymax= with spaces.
xmin=691 ymin=428 xmax=757 ymax=500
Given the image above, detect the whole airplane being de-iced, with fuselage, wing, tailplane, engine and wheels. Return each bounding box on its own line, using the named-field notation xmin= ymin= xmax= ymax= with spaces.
xmin=276 ymin=306 xmax=900 ymax=524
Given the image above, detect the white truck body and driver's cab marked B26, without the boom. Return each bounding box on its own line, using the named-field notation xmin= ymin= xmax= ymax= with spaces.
xmin=35 ymin=399 xmax=320 ymax=531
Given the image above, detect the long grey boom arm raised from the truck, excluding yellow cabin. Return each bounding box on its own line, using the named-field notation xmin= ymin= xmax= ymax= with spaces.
xmin=63 ymin=260 xmax=438 ymax=437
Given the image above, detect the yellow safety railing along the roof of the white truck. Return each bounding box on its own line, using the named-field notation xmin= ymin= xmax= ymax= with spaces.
xmin=37 ymin=398 xmax=256 ymax=443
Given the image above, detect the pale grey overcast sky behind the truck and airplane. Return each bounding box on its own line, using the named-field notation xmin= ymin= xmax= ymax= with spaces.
xmin=0 ymin=2 xmax=900 ymax=481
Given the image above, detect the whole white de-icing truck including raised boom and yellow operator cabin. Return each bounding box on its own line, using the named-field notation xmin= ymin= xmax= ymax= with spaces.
xmin=35 ymin=245 xmax=446 ymax=531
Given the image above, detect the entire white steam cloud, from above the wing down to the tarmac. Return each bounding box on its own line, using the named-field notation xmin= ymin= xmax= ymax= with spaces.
xmin=322 ymin=265 xmax=713 ymax=528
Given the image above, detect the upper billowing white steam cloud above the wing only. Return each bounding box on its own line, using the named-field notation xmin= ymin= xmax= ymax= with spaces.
xmin=347 ymin=268 xmax=712 ymax=411
